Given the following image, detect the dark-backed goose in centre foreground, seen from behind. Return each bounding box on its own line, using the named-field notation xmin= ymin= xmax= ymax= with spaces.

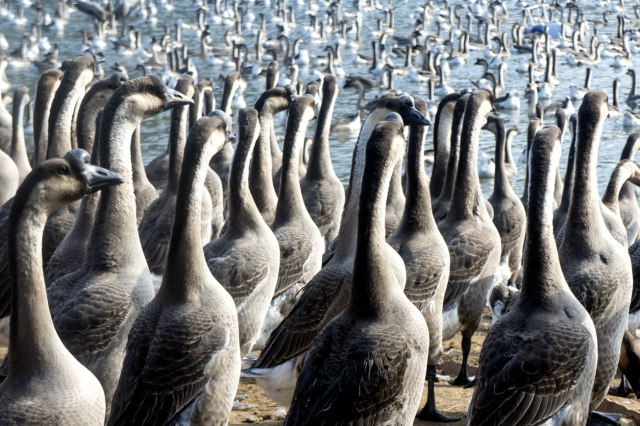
xmin=283 ymin=114 xmax=429 ymax=426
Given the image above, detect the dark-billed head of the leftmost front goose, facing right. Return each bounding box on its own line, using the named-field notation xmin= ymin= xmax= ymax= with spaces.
xmin=23 ymin=149 xmax=124 ymax=212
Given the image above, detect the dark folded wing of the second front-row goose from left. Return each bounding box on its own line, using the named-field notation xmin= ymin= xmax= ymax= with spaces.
xmin=108 ymin=301 xmax=230 ymax=426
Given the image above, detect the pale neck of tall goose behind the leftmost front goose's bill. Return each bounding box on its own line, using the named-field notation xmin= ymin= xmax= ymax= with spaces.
xmin=85 ymin=101 xmax=146 ymax=269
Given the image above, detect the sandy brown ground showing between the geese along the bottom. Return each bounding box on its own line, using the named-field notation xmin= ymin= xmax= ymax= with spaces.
xmin=0 ymin=310 xmax=640 ymax=426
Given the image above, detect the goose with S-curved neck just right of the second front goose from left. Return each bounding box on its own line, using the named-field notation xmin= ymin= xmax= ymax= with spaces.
xmin=204 ymin=105 xmax=280 ymax=357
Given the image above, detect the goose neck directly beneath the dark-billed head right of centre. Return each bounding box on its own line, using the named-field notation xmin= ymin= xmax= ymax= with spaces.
xmin=398 ymin=120 xmax=436 ymax=232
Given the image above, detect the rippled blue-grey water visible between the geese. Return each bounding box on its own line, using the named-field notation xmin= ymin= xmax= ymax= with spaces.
xmin=0 ymin=0 xmax=634 ymax=198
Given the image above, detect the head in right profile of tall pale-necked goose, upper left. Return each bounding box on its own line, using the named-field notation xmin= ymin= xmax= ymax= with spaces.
xmin=112 ymin=74 xmax=193 ymax=119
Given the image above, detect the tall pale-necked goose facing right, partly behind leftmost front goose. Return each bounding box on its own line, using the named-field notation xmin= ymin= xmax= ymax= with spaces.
xmin=21 ymin=74 xmax=191 ymax=418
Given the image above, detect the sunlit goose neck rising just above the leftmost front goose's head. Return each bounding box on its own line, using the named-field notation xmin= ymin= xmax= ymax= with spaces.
xmin=47 ymin=80 xmax=84 ymax=159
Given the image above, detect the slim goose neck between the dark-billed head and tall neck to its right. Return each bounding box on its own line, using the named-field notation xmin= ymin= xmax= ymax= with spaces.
xmin=430 ymin=99 xmax=456 ymax=199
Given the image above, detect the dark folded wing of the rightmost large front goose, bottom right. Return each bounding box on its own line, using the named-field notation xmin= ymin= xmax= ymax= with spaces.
xmin=469 ymin=312 xmax=594 ymax=426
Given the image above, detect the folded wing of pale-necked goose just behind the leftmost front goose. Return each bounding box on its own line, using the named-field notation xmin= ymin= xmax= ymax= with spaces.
xmin=47 ymin=274 xmax=131 ymax=367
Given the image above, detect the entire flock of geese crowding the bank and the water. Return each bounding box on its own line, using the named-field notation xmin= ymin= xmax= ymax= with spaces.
xmin=0 ymin=0 xmax=640 ymax=426
